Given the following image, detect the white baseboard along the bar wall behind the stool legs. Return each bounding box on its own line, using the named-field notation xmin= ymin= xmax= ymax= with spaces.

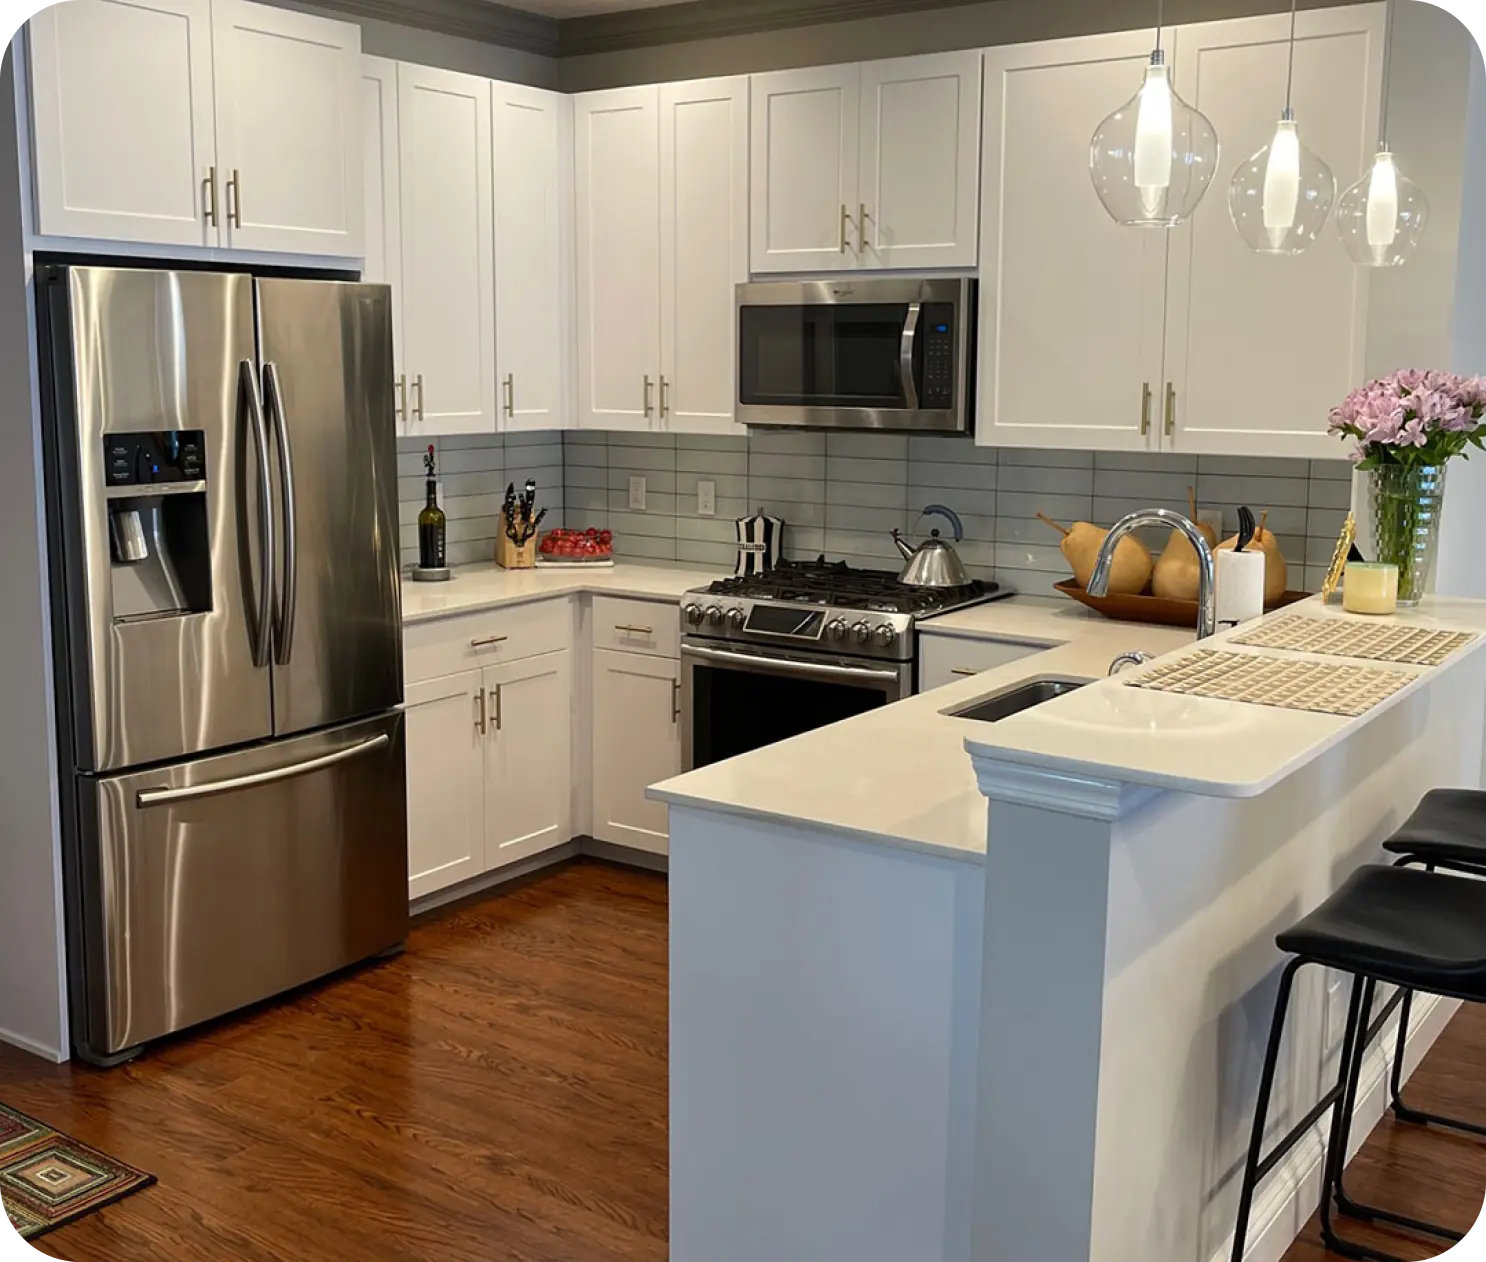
xmin=1211 ymin=994 xmax=1461 ymax=1262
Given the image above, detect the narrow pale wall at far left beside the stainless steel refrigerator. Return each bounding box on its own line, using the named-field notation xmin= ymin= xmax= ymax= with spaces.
xmin=0 ymin=42 xmax=67 ymax=1060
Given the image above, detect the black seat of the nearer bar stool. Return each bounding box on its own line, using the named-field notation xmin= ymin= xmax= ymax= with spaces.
xmin=1275 ymin=865 xmax=1486 ymax=1002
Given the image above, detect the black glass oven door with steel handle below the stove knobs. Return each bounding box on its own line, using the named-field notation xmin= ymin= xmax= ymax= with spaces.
xmin=681 ymin=641 xmax=912 ymax=771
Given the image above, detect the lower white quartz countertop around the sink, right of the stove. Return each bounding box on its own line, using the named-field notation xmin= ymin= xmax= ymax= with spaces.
xmin=649 ymin=599 xmax=1195 ymax=862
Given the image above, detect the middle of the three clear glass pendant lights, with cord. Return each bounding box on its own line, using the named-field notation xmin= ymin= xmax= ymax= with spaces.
xmin=1227 ymin=0 xmax=1336 ymax=254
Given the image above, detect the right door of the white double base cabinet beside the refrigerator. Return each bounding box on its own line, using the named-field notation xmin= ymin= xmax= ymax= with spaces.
xmin=484 ymin=648 xmax=572 ymax=868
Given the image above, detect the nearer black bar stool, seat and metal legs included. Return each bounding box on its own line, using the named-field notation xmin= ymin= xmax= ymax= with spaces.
xmin=1232 ymin=865 xmax=1486 ymax=1262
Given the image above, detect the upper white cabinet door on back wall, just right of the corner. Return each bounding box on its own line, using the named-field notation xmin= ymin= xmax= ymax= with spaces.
xmin=574 ymin=88 xmax=660 ymax=430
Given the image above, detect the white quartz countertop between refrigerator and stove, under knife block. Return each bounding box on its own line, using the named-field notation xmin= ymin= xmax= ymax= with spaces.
xmin=403 ymin=560 xmax=719 ymax=624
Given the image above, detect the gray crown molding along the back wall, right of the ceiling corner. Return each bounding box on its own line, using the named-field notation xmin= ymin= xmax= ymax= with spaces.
xmin=559 ymin=0 xmax=982 ymax=56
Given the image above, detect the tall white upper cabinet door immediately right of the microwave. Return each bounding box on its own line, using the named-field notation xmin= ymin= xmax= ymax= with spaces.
xmin=975 ymin=31 xmax=1167 ymax=450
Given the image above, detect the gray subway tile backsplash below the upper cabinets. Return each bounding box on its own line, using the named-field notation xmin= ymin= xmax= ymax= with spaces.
xmin=398 ymin=430 xmax=1351 ymax=595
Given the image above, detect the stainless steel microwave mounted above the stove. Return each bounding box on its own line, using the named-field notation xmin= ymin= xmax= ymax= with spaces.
xmin=737 ymin=276 xmax=976 ymax=434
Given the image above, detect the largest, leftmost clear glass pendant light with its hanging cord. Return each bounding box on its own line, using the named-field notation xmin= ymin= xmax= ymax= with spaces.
xmin=1089 ymin=0 xmax=1217 ymax=227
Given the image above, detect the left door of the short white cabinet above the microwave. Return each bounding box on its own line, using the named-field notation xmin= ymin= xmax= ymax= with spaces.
xmin=749 ymin=65 xmax=862 ymax=272
